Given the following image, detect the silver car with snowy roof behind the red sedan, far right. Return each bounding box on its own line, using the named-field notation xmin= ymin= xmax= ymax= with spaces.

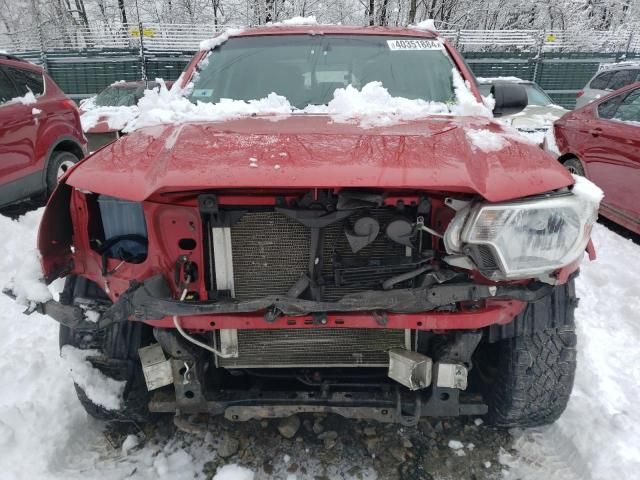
xmin=576 ymin=61 xmax=640 ymax=108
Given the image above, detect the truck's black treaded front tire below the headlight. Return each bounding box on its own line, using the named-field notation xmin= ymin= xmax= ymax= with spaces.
xmin=474 ymin=280 xmax=577 ymax=427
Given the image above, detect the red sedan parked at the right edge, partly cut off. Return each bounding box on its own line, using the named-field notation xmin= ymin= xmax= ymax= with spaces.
xmin=554 ymin=82 xmax=640 ymax=233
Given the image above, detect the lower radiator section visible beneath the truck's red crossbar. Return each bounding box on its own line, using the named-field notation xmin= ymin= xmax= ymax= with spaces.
xmin=216 ymin=328 xmax=410 ymax=368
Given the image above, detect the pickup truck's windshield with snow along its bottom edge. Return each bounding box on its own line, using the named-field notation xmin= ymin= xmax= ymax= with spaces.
xmin=191 ymin=35 xmax=455 ymax=108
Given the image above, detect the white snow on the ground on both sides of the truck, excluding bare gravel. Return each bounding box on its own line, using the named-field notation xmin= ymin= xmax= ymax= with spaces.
xmin=0 ymin=211 xmax=640 ymax=480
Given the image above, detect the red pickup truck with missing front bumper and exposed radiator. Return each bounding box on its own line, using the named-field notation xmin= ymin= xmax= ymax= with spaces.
xmin=28 ymin=25 xmax=599 ymax=426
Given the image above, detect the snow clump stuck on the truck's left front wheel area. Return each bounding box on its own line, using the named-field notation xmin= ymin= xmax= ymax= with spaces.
xmin=60 ymin=345 xmax=126 ymax=410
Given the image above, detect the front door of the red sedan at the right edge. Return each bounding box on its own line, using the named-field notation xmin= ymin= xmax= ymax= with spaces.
xmin=583 ymin=87 xmax=640 ymax=220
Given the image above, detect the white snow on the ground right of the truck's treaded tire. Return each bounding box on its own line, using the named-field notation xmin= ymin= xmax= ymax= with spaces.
xmin=502 ymin=225 xmax=640 ymax=480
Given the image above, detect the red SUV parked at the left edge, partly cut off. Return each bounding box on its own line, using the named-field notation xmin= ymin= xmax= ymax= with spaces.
xmin=0 ymin=54 xmax=86 ymax=207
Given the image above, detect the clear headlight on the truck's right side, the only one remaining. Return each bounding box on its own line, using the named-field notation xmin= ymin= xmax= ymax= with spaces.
xmin=445 ymin=193 xmax=599 ymax=280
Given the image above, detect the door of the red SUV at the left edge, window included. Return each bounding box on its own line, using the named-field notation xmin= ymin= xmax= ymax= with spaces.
xmin=0 ymin=65 xmax=38 ymax=191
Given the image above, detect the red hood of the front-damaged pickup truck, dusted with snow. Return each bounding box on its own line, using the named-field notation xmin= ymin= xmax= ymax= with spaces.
xmin=67 ymin=114 xmax=573 ymax=201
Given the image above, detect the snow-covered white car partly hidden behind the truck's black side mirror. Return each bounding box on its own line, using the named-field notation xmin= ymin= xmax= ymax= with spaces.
xmin=477 ymin=77 xmax=568 ymax=146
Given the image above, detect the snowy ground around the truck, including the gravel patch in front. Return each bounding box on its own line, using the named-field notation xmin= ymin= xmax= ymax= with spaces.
xmin=0 ymin=211 xmax=640 ymax=480
